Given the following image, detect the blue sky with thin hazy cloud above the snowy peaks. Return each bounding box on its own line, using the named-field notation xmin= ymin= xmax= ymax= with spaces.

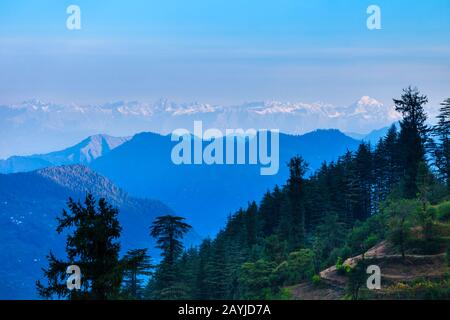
xmin=0 ymin=0 xmax=450 ymax=105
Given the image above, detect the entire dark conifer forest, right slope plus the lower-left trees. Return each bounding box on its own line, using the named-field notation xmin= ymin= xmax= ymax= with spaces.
xmin=37 ymin=87 xmax=450 ymax=299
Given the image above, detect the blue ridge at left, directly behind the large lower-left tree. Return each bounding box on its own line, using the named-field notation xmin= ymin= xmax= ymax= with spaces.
xmin=0 ymin=165 xmax=199 ymax=299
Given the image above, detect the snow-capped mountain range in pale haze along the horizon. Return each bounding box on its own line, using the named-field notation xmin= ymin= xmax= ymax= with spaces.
xmin=0 ymin=96 xmax=400 ymax=158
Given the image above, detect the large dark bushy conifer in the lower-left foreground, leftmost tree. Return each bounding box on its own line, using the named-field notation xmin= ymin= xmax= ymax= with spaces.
xmin=37 ymin=194 xmax=122 ymax=300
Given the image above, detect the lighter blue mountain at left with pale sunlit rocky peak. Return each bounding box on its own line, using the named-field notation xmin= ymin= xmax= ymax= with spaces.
xmin=0 ymin=134 xmax=130 ymax=173
